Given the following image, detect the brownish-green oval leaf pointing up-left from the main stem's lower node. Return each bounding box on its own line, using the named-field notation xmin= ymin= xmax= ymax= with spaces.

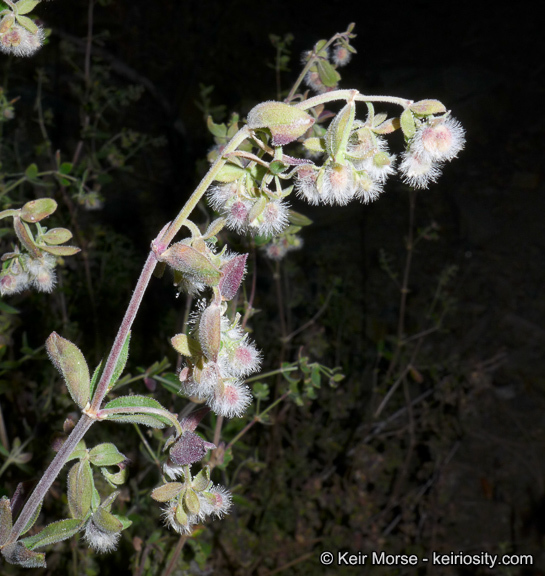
xmin=45 ymin=332 xmax=90 ymax=410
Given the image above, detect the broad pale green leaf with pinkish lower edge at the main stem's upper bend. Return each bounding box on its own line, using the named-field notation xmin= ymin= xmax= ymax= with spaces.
xmin=248 ymin=101 xmax=314 ymax=146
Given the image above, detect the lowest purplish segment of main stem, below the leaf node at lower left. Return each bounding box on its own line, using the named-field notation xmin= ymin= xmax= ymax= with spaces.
xmin=6 ymin=414 xmax=95 ymax=544
